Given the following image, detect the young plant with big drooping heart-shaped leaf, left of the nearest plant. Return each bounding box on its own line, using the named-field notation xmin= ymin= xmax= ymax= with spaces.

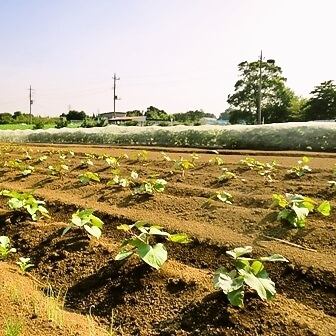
xmin=114 ymin=221 xmax=190 ymax=269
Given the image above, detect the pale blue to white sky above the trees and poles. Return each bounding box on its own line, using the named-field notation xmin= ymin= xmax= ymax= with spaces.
xmin=0 ymin=0 xmax=336 ymax=116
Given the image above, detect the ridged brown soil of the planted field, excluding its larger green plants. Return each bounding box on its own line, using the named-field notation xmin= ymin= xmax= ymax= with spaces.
xmin=0 ymin=144 xmax=336 ymax=336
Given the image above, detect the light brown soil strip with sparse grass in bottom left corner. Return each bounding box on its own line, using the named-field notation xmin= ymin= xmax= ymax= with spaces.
xmin=0 ymin=262 xmax=111 ymax=336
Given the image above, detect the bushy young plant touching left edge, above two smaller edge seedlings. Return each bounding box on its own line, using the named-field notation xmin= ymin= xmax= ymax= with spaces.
xmin=0 ymin=190 xmax=50 ymax=221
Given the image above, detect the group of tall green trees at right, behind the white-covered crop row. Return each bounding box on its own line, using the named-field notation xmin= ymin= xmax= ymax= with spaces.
xmin=219 ymin=60 xmax=336 ymax=124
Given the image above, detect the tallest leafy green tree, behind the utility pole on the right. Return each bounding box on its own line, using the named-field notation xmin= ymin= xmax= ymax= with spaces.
xmin=227 ymin=60 xmax=293 ymax=123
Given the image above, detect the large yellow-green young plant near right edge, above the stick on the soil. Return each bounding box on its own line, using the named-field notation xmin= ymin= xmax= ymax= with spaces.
xmin=271 ymin=194 xmax=331 ymax=228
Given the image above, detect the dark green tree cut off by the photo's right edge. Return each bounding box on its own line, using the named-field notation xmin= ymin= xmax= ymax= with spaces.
xmin=304 ymin=80 xmax=336 ymax=120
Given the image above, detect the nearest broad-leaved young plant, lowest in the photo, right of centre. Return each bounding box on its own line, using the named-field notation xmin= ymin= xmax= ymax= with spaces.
xmin=213 ymin=246 xmax=288 ymax=308
